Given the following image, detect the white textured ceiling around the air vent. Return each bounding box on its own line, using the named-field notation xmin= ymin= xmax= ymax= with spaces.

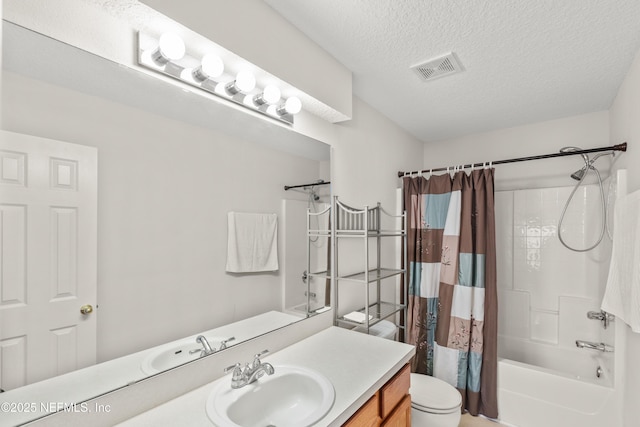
xmin=265 ymin=0 xmax=640 ymax=141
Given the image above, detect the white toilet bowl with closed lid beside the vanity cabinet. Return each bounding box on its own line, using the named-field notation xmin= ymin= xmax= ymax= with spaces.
xmin=409 ymin=374 xmax=462 ymax=427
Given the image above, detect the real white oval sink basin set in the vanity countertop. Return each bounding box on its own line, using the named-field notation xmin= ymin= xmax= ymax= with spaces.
xmin=206 ymin=365 xmax=335 ymax=427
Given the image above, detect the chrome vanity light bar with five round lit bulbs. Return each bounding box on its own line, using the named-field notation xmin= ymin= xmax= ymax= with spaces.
xmin=138 ymin=32 xmax=302 ymax=125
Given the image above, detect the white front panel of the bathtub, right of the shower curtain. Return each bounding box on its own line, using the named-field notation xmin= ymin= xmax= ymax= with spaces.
xmin=498 ymin=359 xmax=621 ymax=427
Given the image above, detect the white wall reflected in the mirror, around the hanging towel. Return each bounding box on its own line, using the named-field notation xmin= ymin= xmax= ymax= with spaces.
xmin=2 ymin=72 xmax=320 ymax=361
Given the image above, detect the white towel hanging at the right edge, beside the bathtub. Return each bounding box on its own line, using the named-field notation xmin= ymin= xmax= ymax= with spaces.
xmin=601 ymin=191 xmax=640 ymax=332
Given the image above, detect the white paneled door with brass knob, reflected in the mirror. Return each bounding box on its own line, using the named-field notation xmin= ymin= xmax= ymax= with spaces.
xmin=0 ymin=131 xmax=98 ymax=390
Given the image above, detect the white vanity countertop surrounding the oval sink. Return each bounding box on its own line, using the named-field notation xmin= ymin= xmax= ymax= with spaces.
xmin=118 ymin=327 xmax=414 ymax=427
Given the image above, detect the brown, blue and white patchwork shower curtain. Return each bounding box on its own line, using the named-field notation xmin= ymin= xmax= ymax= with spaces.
xmin=403 ymin=169 xmax=498 ymax=418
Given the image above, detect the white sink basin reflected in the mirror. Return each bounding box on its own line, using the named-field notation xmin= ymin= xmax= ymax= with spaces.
xmin=140 ymin=337 xmax=225 ymax=375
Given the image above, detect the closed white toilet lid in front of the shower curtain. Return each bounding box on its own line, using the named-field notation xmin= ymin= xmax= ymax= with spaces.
xmin=409 ymin=374 xmax=462 ymax=413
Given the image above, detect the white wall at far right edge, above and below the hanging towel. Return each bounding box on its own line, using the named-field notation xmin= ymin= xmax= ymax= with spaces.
xmin=609 ymin=47 xmax=640 ymax=427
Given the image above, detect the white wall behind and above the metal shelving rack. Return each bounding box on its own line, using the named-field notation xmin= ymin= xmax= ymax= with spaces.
xmin=330 ymin=97 xmax=422 ymax=315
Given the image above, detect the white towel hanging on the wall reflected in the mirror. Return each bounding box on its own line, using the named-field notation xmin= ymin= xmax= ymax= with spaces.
xmin=226 ymin=212 xmax=278 ymax=273
